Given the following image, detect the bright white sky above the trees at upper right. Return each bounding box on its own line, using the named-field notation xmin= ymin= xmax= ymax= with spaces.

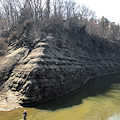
xmin=75 ymin=0 xmax=120 ymax=24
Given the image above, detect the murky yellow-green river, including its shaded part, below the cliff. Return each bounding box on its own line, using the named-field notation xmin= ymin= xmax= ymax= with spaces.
xmin=0 ymin=73 xmax=120 ymax=120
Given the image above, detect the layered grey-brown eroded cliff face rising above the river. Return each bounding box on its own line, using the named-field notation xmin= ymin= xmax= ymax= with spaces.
xmin=0 ymin=23 xmax=120 ymax=107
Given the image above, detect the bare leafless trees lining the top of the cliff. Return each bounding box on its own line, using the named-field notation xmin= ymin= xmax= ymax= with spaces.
xmin=0 ymin=0 xmax=120 ymax=54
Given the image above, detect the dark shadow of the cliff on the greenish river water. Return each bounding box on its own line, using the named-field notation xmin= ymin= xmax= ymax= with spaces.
xmin=31 ymin=73 xmax=120 ymax=111
